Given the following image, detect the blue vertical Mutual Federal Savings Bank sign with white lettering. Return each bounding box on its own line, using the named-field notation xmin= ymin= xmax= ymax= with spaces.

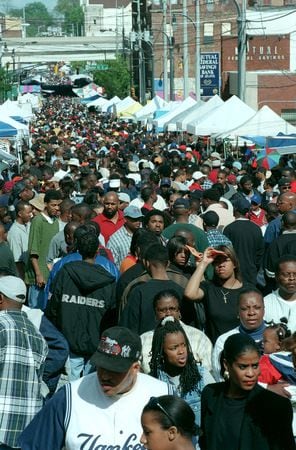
xmin=200 ymin=52 xmax=220 ymax=97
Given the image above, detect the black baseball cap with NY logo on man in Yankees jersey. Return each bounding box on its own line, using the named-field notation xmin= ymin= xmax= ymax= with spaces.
xmin=90 ymin=327 xmax=142 ymax=373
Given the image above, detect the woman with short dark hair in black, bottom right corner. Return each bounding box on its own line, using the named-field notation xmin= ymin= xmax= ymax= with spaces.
xmin=199 ymin=334 xmax=295 ymax=450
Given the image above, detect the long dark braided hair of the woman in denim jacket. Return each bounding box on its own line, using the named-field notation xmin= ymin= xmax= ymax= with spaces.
xmin=149 ymin=316 xmax=201 ymax=396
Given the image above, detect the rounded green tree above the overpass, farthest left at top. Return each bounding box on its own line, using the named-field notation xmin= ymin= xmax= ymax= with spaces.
xmin=9 ymin=2 xmax=53 ymax=37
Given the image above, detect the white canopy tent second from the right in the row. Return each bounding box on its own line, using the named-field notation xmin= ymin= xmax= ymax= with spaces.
xmin=187 ymin=95 xmax=256 ymax=136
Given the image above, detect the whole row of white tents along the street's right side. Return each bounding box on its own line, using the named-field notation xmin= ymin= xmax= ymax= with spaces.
xmin=88 ymin=95 xmax=296 ymax=138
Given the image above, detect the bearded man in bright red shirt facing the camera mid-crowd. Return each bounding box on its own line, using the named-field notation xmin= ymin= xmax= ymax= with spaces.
xmin=93 ymin=191 xmax=125 ymax=244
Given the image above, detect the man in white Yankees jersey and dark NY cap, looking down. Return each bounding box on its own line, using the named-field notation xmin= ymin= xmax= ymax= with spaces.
xmin=20 ymin=327 xmax=168 ymax=450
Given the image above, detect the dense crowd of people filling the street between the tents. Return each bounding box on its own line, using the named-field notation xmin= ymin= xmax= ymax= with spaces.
xmin=0 ymin=97 xmax=296 ymax=450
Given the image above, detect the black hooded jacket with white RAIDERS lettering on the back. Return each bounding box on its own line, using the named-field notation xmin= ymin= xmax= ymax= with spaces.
xmin=46 ymin=261 xmax=116 ymax=358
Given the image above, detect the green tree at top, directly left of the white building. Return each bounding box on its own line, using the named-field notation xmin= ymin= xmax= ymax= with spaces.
xmin=55 ymin=0 xmax=84 ymax=36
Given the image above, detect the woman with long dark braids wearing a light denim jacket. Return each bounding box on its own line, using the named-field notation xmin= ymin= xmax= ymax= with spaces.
xmin=150 ymin=316 xmax=214 ymax=425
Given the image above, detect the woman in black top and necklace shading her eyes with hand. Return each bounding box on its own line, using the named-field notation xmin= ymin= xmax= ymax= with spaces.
xmin=184 ymin=245 xmax=251 ymax=344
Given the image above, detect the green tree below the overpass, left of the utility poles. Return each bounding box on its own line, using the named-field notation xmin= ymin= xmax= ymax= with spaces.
xmin=93 ymin=57 xmax=130 ymax=98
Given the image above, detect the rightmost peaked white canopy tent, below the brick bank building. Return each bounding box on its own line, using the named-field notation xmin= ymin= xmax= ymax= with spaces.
xmin=219 ymin=105 xmax=296 ymax=137
